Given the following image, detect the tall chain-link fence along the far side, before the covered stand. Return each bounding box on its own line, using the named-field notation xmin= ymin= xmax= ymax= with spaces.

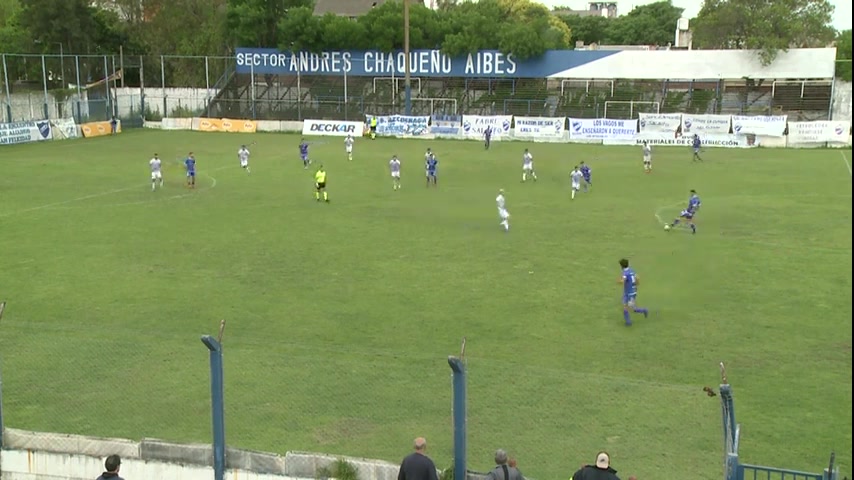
xmin=0 ymin=54 xmax=851 ymax=125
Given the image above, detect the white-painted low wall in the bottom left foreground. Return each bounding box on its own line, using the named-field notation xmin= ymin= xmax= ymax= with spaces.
xmin=0 ymin=450 xmax=295 ymax=480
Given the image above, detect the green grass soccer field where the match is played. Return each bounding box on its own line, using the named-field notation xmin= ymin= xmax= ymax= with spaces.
xmin=0 ymin=131 xmax=852 ymax=480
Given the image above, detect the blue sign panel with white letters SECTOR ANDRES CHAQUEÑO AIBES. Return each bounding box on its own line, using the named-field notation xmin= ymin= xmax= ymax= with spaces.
xmin=237 ymin=48 xmax=618 ymax=78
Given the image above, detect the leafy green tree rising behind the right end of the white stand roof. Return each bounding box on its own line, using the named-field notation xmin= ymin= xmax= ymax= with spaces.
xmin=693 ymin=0 xmax=834 ymax=65
